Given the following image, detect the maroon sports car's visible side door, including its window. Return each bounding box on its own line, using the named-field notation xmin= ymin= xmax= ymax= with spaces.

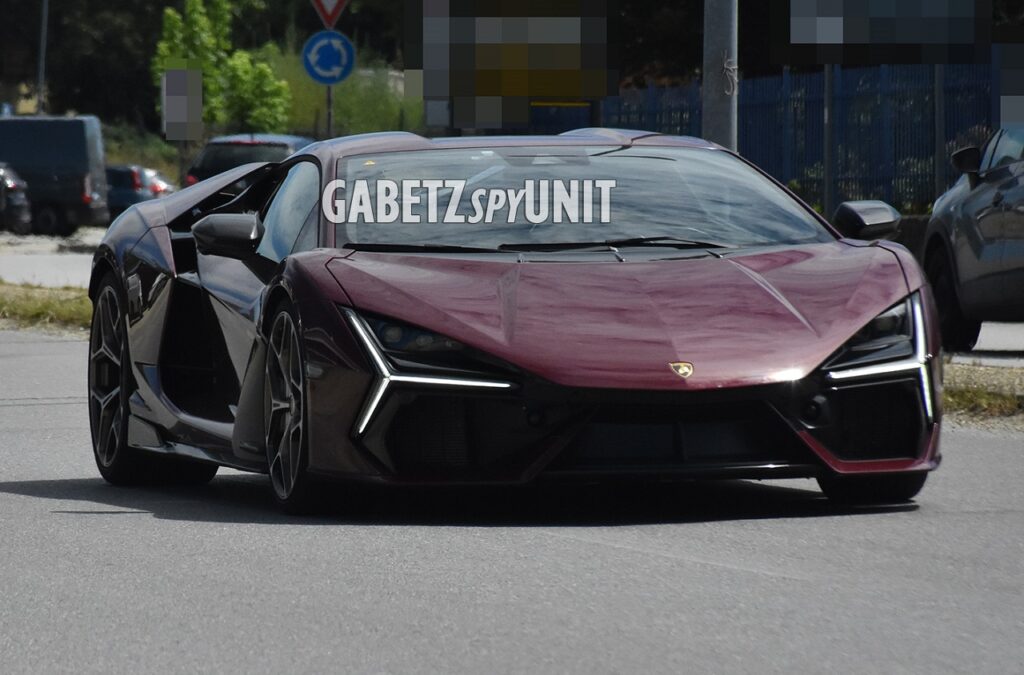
xmin=192 ymin=161 xmax=319 ymax=395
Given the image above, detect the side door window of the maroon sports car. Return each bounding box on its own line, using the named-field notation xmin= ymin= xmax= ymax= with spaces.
xmin=257 ymin=162 xmax=319 ymax=262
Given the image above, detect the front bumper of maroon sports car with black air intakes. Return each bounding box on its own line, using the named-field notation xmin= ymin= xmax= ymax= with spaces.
xmin=311 ymin=307 xmax=941 ymax=483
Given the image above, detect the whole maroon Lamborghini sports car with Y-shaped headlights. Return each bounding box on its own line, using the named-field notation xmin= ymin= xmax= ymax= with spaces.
xmin=89 ymin=129 xmax=941 ymax=510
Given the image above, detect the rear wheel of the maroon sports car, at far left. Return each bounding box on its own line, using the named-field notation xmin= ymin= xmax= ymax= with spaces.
xmin=89 ymin=272 xmax=217 ymax=486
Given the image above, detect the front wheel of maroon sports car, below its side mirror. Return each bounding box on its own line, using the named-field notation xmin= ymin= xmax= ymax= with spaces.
xmin=263 ymin=300 xmax=318 ymax=514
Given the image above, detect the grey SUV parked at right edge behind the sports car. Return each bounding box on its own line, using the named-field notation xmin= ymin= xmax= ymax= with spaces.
xmin=919 ymin=126 xmax=1024 ymax=351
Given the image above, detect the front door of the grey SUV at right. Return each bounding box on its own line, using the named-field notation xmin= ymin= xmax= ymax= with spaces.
xmin=953 ymin=131 xmax=1011 ymax=317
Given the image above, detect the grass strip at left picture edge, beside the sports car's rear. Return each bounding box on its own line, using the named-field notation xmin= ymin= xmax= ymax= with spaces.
xmin=0 ymin=282 xmax=92 ymax=328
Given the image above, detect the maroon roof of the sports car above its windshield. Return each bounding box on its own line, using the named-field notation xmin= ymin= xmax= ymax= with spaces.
xmin=302 ymin=128 xmax=721 ymax=162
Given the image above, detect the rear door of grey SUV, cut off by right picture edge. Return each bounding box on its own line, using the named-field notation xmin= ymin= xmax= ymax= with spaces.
xmin=993 ymin=127 xmax=1024 ymax=321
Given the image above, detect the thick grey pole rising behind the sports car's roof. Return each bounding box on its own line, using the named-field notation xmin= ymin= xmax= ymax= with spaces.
xmin=700 ymin=0 xmax=739 ymax=151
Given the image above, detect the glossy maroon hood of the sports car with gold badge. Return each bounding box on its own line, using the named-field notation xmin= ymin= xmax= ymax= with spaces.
xmin=328 ymin=242 xmax=908 ymax=389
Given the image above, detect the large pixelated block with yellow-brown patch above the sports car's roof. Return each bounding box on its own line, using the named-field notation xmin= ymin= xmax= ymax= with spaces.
xmin=403 ymin=0 xmax=620 ymax=129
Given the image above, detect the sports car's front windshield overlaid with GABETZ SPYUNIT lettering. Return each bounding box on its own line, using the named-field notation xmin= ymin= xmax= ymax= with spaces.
xmin=333 ymin=145 xmax=834 ymax=250
